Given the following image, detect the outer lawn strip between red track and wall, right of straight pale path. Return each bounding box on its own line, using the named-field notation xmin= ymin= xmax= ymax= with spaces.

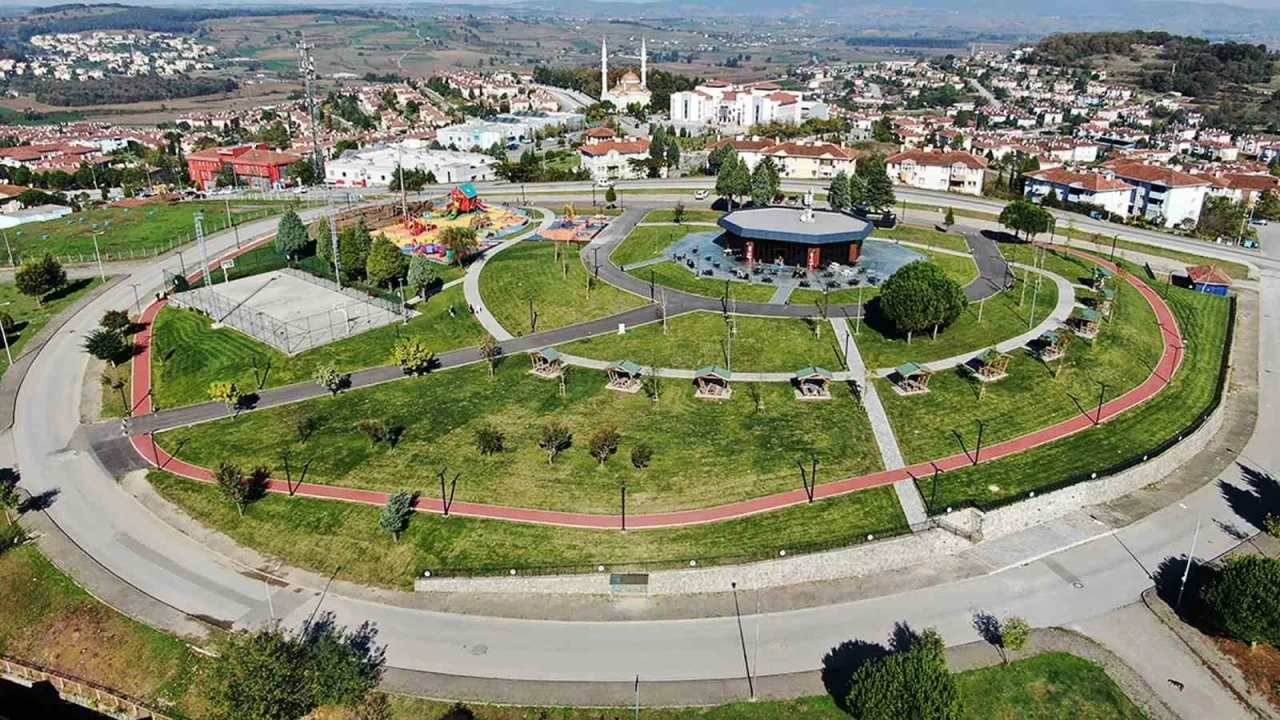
xmin=926 ymin=278 xmax=1230 ymax=507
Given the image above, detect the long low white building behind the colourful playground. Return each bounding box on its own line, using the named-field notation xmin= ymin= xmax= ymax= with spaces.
xmin=324 ymin=140 xmax=497 ymax=187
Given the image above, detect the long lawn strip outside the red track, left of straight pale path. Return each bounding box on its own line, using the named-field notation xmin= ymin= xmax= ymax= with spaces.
xmin=148 ymin=468 xmax=906 ymax=589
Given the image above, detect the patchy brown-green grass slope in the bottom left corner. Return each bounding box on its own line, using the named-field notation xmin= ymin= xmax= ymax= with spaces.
xmin=0 ymin=544 xmax=205 ymax=717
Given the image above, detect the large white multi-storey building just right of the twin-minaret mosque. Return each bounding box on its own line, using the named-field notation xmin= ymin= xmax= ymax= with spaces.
xmin=669 ymin=81 xmax=828 ymax=128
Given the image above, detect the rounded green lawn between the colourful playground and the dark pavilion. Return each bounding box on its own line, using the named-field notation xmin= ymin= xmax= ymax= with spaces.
xmin=480 ymin=241 xmax=645 ymax=334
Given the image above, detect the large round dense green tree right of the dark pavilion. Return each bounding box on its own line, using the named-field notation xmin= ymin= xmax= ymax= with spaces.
xmin=879 ymin=261 xmax=965 ymax=342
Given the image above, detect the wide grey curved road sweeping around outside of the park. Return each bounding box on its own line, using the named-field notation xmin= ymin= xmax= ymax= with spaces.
xmin=10 ymin=181 xmax=1280 ymax=703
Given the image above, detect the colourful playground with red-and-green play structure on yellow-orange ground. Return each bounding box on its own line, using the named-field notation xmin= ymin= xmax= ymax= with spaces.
xmin=374 ymin=183 xmax=529 ymax=265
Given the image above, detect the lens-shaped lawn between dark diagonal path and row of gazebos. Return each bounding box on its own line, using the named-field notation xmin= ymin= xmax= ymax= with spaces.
xmin=559 ymin=313 xmax=844 ymax=373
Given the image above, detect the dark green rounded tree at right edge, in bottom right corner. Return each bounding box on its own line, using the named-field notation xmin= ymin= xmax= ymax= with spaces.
xmin=1204 ymin=555 xmax=1280 ymax=647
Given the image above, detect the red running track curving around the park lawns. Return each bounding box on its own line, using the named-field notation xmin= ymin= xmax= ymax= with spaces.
xmin=131 ymin=247 xmax=1183 ymax=529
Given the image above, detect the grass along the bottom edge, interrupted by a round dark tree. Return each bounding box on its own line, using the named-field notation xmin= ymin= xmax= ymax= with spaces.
xmin=376 ymin=652 xmax=1146 ymax=720
